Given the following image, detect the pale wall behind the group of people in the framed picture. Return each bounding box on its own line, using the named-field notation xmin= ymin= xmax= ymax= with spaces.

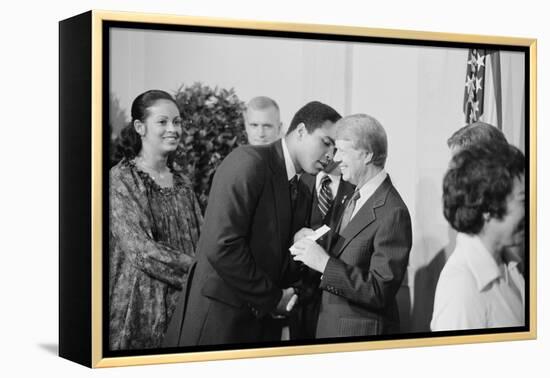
xmin=109 ymin=29 xmax=525 ymax=332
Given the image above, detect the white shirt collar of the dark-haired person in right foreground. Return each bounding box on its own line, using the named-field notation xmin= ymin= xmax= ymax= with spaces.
xmin=456 ymin=233 xmax=504 ymax=291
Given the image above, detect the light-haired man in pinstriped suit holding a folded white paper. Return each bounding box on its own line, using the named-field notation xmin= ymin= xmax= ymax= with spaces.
xmin=292 ymin=114 xmax=412 ymax=338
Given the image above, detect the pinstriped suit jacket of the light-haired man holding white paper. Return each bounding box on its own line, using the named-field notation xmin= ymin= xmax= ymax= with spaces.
xmin=316 ymin=176 xmax=412 ymax=338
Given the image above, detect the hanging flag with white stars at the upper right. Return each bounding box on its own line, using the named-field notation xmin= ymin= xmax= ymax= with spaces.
xmin=464 ymin=49 xmax=502 ymax=129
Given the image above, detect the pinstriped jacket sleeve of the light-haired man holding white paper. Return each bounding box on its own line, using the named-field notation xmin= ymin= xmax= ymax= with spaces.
xmin=320 ymin=208 xmax=412 ymax=310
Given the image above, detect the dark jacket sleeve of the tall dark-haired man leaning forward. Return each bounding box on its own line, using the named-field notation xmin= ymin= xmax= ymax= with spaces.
xmin=199 ymin=148 xmax=282 ymax=317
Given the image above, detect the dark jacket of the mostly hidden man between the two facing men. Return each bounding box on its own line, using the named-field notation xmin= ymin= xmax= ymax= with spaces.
xmin=290 ymin=173 xmax=355 ymax=340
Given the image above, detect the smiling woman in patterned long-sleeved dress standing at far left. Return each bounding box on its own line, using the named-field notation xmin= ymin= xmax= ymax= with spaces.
xmin=109 ymin=90 xmax=202 ymax=350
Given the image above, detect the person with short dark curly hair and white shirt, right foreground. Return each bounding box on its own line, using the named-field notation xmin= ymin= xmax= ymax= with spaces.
xmin=431 ymin=143 xmax=525 ymax=331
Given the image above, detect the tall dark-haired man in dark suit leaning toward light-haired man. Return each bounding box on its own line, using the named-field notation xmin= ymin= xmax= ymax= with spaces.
xmin=179 ymin=102 xmax=341 ymax=346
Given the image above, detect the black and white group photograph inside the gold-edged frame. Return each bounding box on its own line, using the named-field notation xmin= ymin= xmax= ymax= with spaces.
xmin=103 ymin=18 xmax=531 ymax=357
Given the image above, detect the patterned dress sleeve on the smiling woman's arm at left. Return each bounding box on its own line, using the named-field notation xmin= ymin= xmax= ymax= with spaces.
xmin=109 ymin=174 xmax=193 ymax=289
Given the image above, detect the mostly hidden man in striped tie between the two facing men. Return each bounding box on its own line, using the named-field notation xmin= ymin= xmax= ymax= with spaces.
xmin=290 ymin=160 xmax=355 ymax=340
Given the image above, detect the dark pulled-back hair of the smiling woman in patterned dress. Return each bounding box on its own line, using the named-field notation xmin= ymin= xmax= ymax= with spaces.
xmin=113 ymin=89 xmax=178 ymax=162
